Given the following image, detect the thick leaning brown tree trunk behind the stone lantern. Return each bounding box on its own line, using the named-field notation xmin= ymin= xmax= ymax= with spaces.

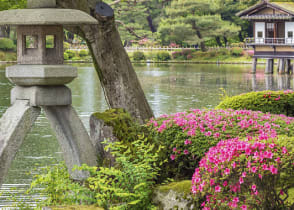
xmin=57 ymin=0 xmax=153 ymax=123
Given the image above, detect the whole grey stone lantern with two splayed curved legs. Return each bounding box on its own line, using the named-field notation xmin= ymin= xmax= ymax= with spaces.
xmin=0 ymin=0 xmax=97 ymax=186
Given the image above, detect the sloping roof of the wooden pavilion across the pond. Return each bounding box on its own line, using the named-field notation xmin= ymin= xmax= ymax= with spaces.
xmin=236 ymin=1 xmax=294 ymax=20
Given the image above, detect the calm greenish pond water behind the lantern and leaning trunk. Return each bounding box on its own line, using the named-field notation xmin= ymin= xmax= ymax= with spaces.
xmin=0 ymin=64 xmax=294 ymax=209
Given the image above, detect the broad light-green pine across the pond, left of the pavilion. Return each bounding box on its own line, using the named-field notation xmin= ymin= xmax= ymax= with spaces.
xmin=158 ymin=0 xmax=240 ymax=51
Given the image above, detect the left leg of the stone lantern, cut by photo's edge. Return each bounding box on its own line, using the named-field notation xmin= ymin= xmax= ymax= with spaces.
xmin=0 ymin=100 xmax=40 ymax=186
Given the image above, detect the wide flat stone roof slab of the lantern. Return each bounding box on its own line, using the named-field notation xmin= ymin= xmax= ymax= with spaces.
xmin=0 ymin=8 xmax=97 ymax=25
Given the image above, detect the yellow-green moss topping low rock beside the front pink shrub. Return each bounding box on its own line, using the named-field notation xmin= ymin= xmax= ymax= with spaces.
xmin=158 ymin=180 xmax=192 ymax=195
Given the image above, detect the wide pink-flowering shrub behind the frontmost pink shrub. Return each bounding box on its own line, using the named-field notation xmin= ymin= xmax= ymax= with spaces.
xmin=148 ymin=109 xmax=294 ymax=179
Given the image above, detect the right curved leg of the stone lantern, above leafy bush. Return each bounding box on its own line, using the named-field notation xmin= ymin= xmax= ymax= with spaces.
xmin=42 ymin=105 xmax=97 ymax=180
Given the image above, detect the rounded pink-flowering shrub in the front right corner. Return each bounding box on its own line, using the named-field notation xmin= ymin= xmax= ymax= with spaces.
xmin=192 ymin=136 xmax=294 ymax=210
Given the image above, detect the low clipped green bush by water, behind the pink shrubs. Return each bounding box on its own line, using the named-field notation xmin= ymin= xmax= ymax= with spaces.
xmin=216 ymin=90 xmax=294 ymax=116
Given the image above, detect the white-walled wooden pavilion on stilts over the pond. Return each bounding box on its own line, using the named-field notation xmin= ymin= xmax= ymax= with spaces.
xmin=237 ymin=0 xmax=294 ymax=73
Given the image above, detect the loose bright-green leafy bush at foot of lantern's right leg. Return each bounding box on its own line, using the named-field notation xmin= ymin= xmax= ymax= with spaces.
xmin=30 ymin=136 xmax=161 ymax=210
